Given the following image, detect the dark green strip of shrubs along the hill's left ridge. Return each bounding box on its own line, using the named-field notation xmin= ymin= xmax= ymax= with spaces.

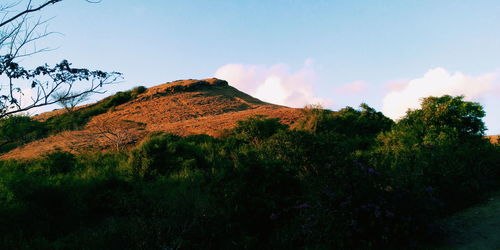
xmin=0 ymin=86 xmax=147 ymax=153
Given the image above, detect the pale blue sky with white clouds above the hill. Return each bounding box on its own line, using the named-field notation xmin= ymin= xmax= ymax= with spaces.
xmin=15 ymin=0 xmax=500 ymax=134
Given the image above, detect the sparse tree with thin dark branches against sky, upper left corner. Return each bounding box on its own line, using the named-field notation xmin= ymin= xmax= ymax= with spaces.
xmin=0 ymin=0 xmax=121 ymax=118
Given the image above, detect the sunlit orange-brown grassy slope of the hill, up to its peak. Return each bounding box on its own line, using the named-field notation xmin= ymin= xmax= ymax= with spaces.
xmin=1 ymin=78 xmax=300 ymax=159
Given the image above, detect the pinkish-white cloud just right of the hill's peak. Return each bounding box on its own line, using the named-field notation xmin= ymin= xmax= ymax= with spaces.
xmin=215 ymin=59 xmax=330 ymax=107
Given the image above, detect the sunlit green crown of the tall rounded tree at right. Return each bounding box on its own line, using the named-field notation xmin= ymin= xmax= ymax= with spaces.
xmin=378 ymin=95 xmax=485 ymax=160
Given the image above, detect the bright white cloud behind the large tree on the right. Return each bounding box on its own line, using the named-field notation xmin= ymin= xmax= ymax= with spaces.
xmin=382 ymin=68 xmax=496 ymax=119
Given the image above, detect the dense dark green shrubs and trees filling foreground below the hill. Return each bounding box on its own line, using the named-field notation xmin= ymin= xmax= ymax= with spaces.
xmin=0 ymin=96 xmax=500 ymax=249
